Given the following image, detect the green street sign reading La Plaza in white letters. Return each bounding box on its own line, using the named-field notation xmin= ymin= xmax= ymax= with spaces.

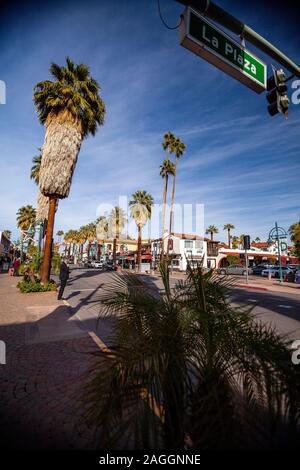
xmin=180 ymin=7 xmax=267 ymax=93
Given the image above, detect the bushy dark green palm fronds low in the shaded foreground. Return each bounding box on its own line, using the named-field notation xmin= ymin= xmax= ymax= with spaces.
xmin=84 ymin=263 xmax=300 ymax=450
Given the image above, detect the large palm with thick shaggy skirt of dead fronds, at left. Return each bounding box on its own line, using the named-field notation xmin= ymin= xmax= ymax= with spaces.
xmin=34 ymin=57 xmax=105 ymax=283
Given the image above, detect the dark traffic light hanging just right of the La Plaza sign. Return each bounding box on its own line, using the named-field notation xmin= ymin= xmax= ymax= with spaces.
xmin=267 ymin=67 xmax=290 ymax=116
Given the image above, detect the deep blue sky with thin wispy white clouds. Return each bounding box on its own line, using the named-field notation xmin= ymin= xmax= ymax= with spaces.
xmin=0 ymin=0 xmax=300 ymax=240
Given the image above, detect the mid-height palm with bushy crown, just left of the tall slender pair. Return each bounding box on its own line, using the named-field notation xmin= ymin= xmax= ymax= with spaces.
xmin=129 ymin=190 xmax=153 ymax=271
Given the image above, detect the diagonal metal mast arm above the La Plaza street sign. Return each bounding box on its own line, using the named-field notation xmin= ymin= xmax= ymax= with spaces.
xmin=176 ymin=0 xmax=300 ymax=78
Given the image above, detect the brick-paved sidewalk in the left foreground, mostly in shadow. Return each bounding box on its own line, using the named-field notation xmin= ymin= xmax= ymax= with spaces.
xmin=0 ymin=274 xmax=98 ymax=449
